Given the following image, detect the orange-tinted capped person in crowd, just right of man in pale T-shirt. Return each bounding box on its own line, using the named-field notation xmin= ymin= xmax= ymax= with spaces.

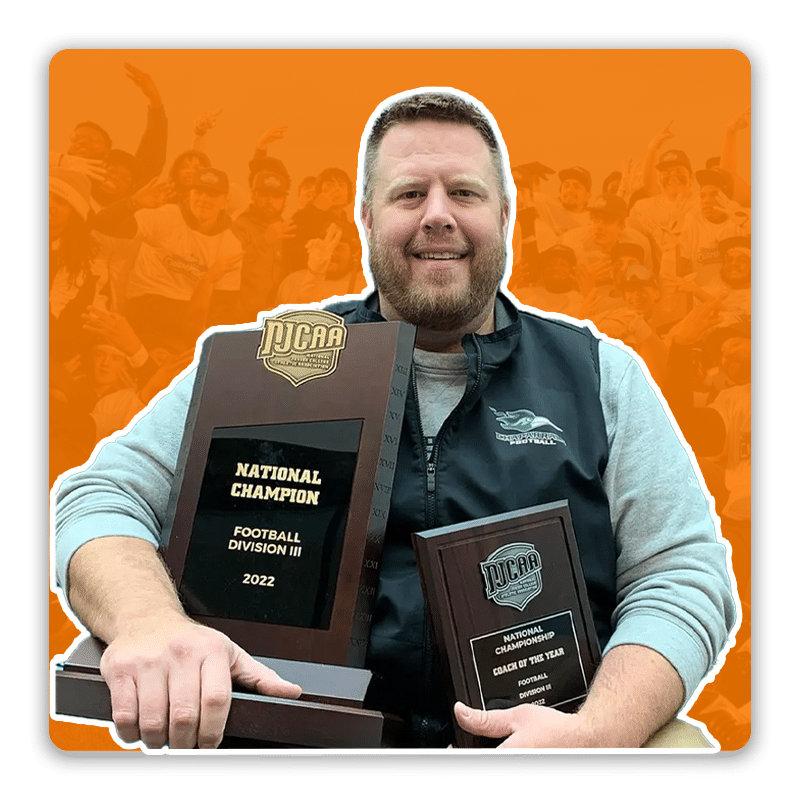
xmin=232 ymin=163 xmax=294 ymax=319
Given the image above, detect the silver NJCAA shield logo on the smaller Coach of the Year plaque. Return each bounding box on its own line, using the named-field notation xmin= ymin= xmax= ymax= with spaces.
xmin=481 ymin=542 xmax=542 ymax=611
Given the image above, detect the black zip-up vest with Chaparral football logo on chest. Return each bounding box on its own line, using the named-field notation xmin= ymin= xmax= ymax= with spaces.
xmin=330 ymin=296 xmax=617 ymax=746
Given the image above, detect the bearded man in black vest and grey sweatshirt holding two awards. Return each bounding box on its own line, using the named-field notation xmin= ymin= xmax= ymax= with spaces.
xmin=53 ymin=90 xmax=734 ymax=747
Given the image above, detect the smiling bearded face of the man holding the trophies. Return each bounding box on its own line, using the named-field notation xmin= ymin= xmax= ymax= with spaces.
xmin=361 ymin=120 xmax=509 ymax=331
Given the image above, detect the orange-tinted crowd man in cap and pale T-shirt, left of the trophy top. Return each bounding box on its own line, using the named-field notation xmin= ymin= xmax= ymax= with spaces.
xmin=95 ymin=167 xmax=242 ymax=352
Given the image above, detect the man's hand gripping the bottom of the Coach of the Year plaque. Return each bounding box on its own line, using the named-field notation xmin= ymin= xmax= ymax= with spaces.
xmin=455 ymin=703 xmax=599 ymax=749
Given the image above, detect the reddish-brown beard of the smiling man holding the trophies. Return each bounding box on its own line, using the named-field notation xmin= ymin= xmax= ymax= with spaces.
xmin=369 ymin=233 xmax=506 ymax=331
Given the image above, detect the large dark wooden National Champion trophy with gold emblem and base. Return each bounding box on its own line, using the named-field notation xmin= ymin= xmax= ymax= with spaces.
xmin=56 ymin=309 xmax=414 ymax=747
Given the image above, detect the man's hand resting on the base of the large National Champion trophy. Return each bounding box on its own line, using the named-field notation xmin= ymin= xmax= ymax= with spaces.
xmin=100 ymin=612 xmax=302 ymax=749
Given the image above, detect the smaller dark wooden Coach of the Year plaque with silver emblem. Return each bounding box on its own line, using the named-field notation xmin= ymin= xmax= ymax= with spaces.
xmin=413 ymin=501 xmax=600 ymax=747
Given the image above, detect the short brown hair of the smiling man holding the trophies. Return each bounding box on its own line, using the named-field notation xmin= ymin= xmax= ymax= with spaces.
xmin=363 ymin=92 xmax=509 ymax=206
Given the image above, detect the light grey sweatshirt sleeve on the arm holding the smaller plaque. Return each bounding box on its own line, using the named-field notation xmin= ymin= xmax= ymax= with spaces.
xmin=600 ymin=342 xmax=737 ymax=700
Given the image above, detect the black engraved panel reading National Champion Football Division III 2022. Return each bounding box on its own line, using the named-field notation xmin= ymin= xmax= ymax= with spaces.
xmin=180 ymin=420 xmax=362 ymax=629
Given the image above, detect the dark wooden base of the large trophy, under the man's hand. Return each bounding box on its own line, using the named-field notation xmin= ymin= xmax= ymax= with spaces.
xmin=55 ymin=637 xmax=404 ymax=749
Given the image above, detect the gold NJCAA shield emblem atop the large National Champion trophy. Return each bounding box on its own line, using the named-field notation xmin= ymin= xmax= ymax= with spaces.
xmin=256 ymin=309 xmax=347 ymax=386
